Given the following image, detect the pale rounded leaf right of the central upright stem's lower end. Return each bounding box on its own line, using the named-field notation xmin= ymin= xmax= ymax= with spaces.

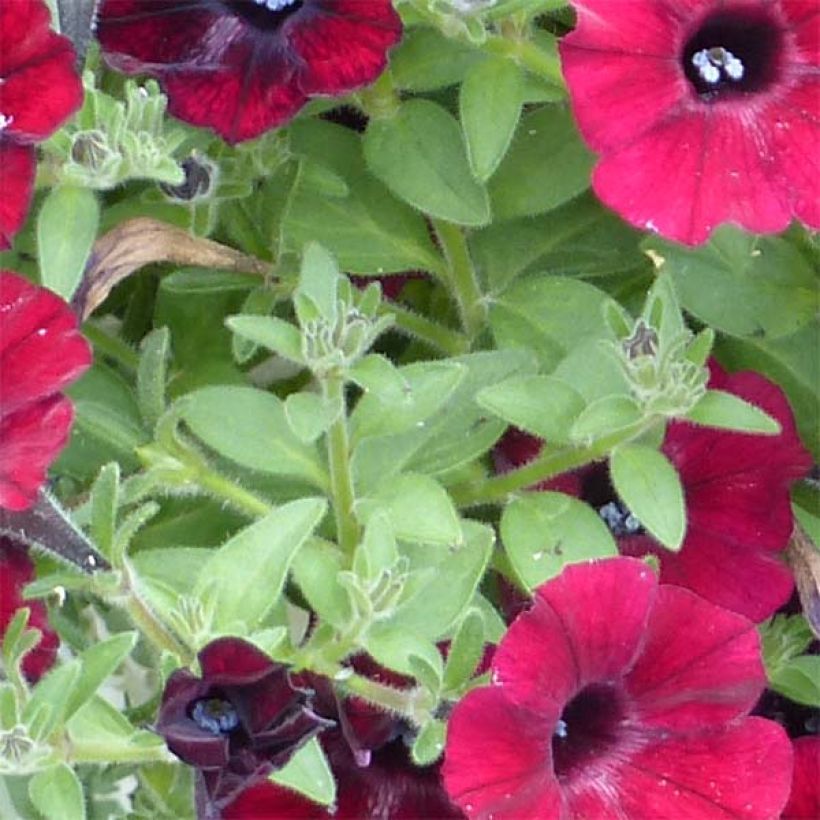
xmin=356 ymin=473 xmax=462 ymax=545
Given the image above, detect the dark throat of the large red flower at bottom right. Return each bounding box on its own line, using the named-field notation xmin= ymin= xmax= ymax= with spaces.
xmin=552 ymin=683 xmax=625 ymax=779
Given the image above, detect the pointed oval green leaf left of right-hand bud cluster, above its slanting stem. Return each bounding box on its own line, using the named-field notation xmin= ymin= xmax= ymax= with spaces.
xmin=476 ymin=376 xmax=585 ymax=443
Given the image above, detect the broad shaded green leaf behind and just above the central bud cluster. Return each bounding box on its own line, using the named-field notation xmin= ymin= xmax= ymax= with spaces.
xmin=282 ymin=118 xmax=443 ymax=274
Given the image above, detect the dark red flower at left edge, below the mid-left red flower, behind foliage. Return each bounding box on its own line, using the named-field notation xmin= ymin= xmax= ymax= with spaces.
xmin=0 ymin=538 xmax=60 ymax=683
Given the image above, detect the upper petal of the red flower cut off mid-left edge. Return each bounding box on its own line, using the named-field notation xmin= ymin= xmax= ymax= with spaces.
xmin=0 ymin=271 xmax=91 ymax=417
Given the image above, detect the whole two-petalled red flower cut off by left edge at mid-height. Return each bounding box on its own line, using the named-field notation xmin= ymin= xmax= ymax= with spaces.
xmin=0 ymin=271 xmax=91 ymax=511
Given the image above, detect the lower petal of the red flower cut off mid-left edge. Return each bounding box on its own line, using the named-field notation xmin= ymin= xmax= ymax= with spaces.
xmin=0 ymin=395 xmax=74 ymax=510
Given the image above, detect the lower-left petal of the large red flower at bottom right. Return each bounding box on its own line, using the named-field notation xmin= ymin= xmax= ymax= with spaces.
xmin=442 ymin=687 xmax=560 ymax=820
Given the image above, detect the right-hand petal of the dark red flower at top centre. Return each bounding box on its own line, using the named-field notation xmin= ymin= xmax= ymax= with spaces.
xmin=288 ymin=0 xmax=401 ymax=95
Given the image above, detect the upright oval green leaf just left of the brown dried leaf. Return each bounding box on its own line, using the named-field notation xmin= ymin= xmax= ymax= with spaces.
xmin=37 ymin=185 xmax=100 ymax=300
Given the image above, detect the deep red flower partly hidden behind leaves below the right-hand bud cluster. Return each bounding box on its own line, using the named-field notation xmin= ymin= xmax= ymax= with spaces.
xmin=496 ymin=364 xmax=811 ymax=621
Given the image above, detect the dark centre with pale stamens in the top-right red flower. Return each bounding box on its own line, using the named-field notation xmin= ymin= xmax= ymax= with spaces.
xmin=682 ymin=9 xmax=782 ymax=100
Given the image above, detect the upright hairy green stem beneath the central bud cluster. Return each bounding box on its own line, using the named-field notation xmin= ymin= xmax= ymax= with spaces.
xmin=322 ymin=373 xmax=359 ymax=555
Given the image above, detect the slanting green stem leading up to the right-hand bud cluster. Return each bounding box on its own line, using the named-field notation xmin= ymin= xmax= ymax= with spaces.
xmin=450 ymin=419 xmax=657 ymax=507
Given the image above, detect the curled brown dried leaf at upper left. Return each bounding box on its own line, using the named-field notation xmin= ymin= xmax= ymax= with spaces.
xmin=72 ymin=217 xmax=272 ymax=321
